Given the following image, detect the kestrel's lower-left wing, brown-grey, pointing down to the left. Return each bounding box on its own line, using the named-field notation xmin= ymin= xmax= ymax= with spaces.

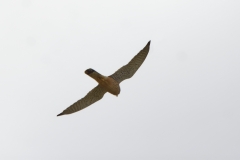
xmin=57 ymin=85 xmax=106 ymax=116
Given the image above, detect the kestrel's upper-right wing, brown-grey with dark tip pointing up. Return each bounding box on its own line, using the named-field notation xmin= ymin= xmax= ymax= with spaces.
xmin=110 ymin=41 xmax=151 ymax=83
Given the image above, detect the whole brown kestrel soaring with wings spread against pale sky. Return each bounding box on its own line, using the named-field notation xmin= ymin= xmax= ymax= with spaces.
xmin=57 ymin=41 xmax=151 ymax=116
